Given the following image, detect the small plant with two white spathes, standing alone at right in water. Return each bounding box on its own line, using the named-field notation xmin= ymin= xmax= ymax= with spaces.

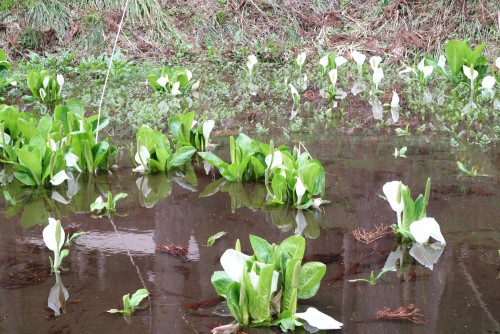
xmin=383 ymin=178 xmax=446 ymax=244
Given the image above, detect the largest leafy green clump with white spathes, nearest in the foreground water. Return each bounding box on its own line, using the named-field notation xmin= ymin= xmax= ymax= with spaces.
xmin=211 ymin=235 xmax=342 ymax=331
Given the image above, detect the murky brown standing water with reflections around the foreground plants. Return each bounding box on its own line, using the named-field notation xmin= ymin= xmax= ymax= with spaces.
xmin=0 ymin=137 xmax=500 ymax=333
